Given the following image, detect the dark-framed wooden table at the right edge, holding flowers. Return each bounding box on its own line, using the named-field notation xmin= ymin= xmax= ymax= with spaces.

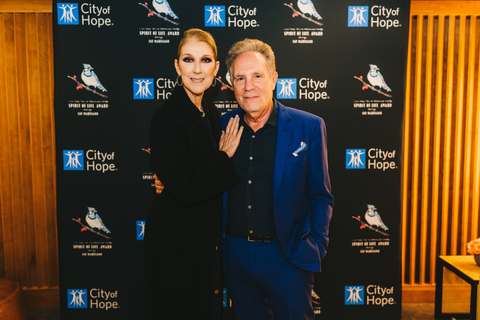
xmin=435 ymin=255 xmax=480 ymax=320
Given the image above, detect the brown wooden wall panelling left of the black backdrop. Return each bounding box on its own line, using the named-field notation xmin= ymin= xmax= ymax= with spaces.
xmin=0 ymin=13 xmax=58 ymax=288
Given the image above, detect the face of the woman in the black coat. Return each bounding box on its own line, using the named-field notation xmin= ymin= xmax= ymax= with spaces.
xmin=175 ymin=39 xmax=219 ymax=103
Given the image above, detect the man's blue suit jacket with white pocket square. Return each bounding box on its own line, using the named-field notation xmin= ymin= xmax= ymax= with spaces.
xmin=221 ymin=103 xmax=333 ymax=272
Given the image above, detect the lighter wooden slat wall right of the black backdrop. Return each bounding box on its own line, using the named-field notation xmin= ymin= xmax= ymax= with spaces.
xmin=402 ymin=1 xmax=480 ymax=300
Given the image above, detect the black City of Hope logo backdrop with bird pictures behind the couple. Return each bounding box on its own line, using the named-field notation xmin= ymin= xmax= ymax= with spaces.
xmin=53 ymin=0 xmax=409 ymax=320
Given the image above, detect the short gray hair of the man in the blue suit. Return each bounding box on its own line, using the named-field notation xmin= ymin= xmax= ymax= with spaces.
xmin=225 ymin=38 xmax=276 ymax=76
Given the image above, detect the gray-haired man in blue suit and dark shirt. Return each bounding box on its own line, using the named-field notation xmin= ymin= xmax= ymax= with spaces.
xmin=156 ymin=39 xmax=333 ymax=320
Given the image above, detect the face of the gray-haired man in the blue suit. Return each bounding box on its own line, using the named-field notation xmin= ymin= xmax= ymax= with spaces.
xmin=232 ymin=52 xmax=278 ymax=116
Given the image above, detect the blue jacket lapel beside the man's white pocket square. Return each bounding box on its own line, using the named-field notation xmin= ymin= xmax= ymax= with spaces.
xmin=273 ymin=102 xmax=293 ymax=203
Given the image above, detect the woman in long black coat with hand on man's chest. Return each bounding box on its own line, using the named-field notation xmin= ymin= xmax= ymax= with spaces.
xmin=144 ymin=29 xmax=243 ymax=320
